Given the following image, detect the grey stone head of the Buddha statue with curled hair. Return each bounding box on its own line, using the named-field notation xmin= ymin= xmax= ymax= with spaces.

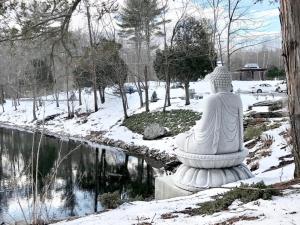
xmin=205 ymin=66 xmax=232 ymax=94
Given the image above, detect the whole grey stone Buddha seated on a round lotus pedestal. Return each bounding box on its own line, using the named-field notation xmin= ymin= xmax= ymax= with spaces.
xmin=173 ymin=66 xmax=252 ymax=192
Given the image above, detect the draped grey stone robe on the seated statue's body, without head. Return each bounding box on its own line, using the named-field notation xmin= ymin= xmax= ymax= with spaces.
xmin=176 ymin=92 xmax=243 ymax=155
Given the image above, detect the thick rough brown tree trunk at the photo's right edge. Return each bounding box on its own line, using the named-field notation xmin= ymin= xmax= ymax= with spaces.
xmin=280 ymin=0 xmax=300 ymax=178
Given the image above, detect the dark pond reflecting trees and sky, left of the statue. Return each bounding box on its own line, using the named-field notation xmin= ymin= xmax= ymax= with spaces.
xmin=0 ymin=128 xmax=163 ymax=224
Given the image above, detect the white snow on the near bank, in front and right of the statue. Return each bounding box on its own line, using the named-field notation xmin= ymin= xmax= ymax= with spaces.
xmin=51 ymin=122 xmax=300 ymax=225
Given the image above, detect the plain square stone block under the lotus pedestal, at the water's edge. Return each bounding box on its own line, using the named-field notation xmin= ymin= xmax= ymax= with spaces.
xmin=155 ymin=175 xmax=194 ymax=200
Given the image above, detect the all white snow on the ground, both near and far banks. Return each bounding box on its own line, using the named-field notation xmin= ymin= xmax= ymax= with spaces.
xmin=0 ymin=81 xmax=300 ymax=225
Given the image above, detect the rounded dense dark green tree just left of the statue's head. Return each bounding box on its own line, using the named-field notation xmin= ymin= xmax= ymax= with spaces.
xmin=154 ymin=17 xmax=216 ymax=105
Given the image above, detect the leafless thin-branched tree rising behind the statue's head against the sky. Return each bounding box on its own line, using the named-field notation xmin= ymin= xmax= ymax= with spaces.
xmin=202 ymin=0 xmax=272 ymax=69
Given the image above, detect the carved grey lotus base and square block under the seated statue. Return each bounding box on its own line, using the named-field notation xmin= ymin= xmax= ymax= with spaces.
xmin=155 ymin=149 xmax=253 ymax=199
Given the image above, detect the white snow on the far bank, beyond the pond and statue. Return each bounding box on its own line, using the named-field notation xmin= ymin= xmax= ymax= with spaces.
xmin=0 ymin=81 xmax=284 ymax=157
